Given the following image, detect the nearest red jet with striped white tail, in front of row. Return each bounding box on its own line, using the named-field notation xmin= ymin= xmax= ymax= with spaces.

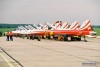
xmin=47 ymin=20 xmax=95 ymax=41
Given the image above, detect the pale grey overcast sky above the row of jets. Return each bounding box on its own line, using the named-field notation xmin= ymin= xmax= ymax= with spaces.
xmin=0 ymin=0 xmax=100 ymax=25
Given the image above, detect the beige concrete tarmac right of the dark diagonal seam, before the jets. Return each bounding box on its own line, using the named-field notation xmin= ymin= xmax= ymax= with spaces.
xmin=0 ymin=37 xmax=100 ymax=67
